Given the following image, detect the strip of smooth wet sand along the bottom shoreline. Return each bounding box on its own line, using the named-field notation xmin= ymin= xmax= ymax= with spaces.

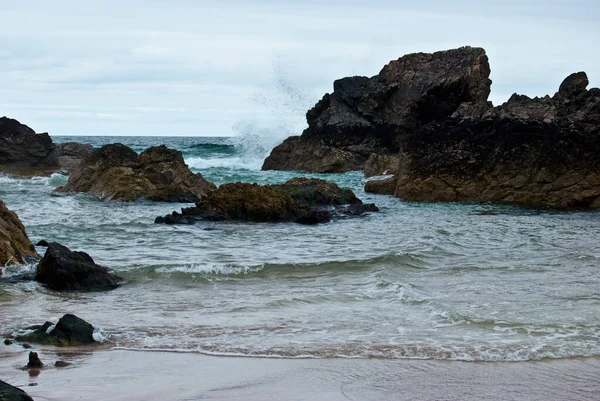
xmin=0 ymin=345 xmax=600 ymax=401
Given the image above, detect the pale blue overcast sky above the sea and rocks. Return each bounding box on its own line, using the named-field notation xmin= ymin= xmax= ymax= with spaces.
xmin=0 ymin=0 xmax=600 ymax=137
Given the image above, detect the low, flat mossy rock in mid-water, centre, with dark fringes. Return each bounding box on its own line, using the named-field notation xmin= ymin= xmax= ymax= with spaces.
xmin=155 ymin=178 xmax=377 ymax=224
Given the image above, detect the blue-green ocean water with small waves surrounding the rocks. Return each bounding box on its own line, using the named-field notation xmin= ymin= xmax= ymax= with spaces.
xmin=0 ymin=136 xmax=600 ymax=362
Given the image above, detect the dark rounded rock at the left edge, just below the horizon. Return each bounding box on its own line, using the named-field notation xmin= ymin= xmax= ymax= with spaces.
xmin=0 ymin=117 xmax=60 ymax=177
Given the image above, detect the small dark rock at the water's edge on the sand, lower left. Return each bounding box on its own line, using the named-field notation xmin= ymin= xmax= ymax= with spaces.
xmin=16 ymin=314 xmax=94 ymax=344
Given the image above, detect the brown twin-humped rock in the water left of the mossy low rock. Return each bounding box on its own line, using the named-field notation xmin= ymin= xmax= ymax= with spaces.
xmin=57 ymin=143 xmax=216 ymax=202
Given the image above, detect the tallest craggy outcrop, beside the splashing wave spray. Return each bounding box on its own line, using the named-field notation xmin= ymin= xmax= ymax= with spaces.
xmin=263 ymin=47 xmax=491 ymax=173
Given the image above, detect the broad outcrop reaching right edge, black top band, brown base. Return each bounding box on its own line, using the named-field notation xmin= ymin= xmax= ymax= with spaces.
xmin=382 ymin=73 xmax=600 ymax=208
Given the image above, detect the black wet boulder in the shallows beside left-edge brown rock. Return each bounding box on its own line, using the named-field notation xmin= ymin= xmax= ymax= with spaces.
xmin=35 ymin=242 xmax=120 ymax=291
